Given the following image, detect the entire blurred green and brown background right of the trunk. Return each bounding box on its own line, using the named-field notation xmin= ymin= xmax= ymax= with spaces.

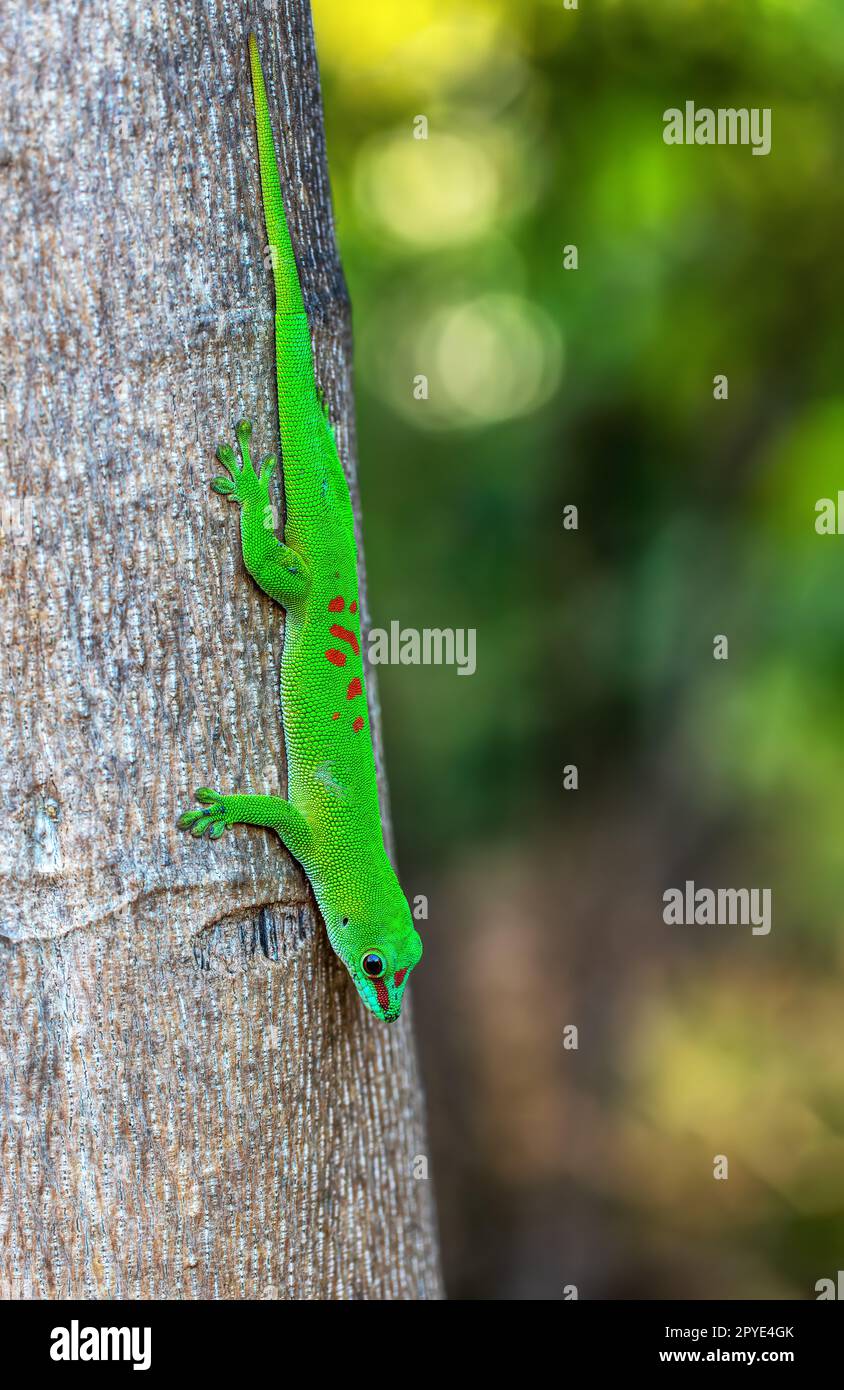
xmin=313 ymin=0 xmax=844 ymax=1298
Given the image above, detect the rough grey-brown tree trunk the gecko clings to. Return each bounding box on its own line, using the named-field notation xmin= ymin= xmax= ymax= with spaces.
xmin=0 ymin=0 xmax=439 ymax=1298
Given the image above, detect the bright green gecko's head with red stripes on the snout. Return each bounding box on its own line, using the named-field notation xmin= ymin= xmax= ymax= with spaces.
xmin=335 ymin=897 xmax=423 ymax=1023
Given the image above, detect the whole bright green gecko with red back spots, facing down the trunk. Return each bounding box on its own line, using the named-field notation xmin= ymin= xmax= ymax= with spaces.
xmin=178 ymin=33 xmax=423 ymax=1023
